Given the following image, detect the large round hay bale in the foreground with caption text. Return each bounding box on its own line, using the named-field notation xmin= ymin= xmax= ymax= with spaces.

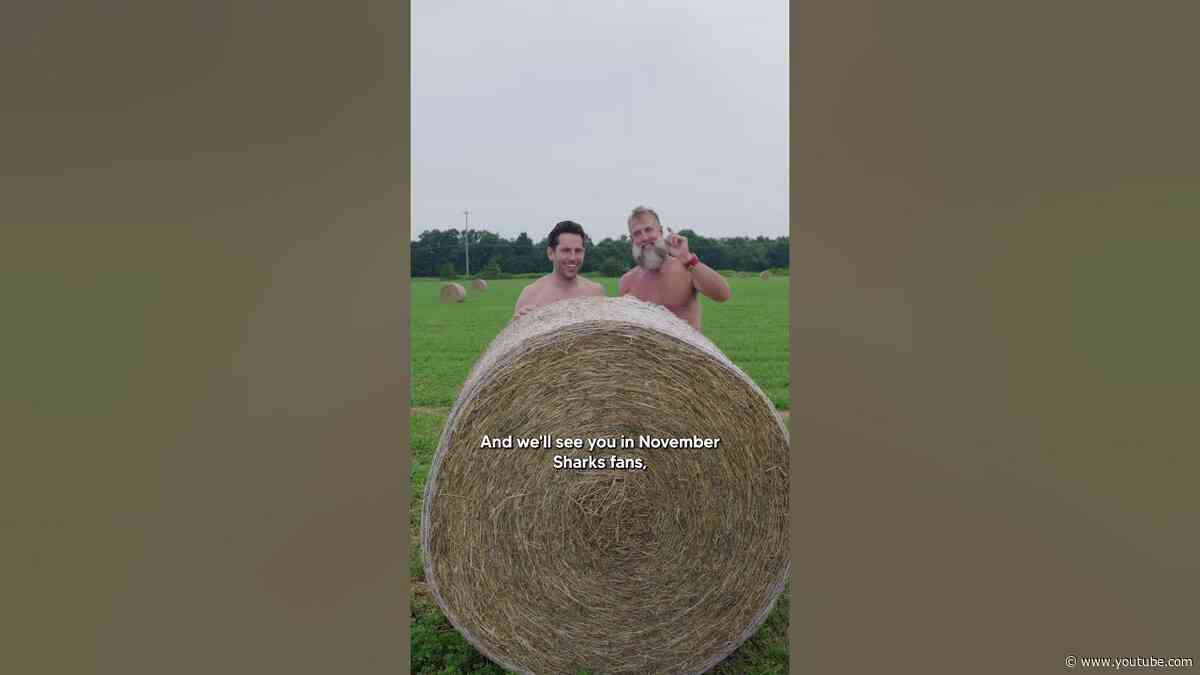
xmin=421 ymin=298 xmax=791 ymax=674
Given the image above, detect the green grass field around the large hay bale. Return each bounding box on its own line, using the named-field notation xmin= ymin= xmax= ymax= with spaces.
xmin=409 ymin=276 xmax=791 ymax=675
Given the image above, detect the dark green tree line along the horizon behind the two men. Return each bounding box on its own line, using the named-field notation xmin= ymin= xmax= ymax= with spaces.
xmin=409 ymin=229 xmax=788 ymax=277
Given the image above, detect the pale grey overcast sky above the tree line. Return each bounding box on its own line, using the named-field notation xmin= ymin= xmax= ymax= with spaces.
xmin=412 ymin=0 xmax=788 ymax=241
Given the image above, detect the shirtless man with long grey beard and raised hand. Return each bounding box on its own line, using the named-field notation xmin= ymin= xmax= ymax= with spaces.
xmin=619 ymin=207 xmax=731 ymax=330
